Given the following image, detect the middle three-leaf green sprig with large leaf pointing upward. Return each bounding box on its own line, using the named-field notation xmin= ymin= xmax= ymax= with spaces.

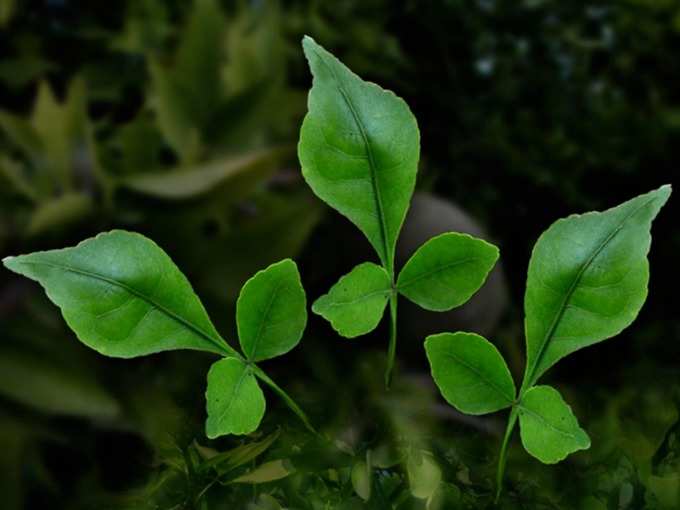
xmin=298 ymin=37 xmax=498 ymax=385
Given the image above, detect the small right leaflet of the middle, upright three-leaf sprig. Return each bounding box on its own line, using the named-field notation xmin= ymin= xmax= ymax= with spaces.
xmin=397 ymin=232 xmax=498 ymax=312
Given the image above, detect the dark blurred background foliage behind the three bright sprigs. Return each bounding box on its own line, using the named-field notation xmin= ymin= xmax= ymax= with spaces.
xmin=0 ymin=0 xmax=680 ymax=510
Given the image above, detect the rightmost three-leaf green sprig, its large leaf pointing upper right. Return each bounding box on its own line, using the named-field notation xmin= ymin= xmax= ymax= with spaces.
xmin=425 ymin=186 xmax=671 ymax=498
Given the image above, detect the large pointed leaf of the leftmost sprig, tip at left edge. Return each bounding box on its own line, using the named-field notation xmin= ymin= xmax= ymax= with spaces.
xmin=3 ymin=230 xmax=235 ymax=358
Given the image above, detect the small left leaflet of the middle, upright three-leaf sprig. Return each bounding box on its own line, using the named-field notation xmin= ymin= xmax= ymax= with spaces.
xmin=312 ymin=262 xmax=392 ymax=338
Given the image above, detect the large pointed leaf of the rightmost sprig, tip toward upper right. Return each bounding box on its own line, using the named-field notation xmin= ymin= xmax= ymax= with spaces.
xmin=524 ymin=186 xmax=671 ymax=387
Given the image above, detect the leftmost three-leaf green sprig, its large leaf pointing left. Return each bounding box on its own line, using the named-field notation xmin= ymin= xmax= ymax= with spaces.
xmin=3 ymin=230 xmax=314 ymax=438
